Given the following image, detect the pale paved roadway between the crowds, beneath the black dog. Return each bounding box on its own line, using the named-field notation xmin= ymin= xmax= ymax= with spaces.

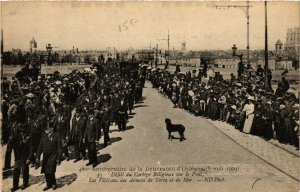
xmin=3 ymin=83 xmax=298 ymax=192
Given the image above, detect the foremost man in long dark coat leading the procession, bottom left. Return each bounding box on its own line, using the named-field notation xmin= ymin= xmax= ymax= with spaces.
xmin=36 ymin=127 xmax=62 ymax=191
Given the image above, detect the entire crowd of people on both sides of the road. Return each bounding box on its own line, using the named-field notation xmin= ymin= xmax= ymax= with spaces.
xmin=1 ymin=61 xmax=299 ymax=191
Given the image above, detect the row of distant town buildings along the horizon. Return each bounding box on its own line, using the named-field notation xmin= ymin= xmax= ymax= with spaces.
xmin=3 ymin=28 xmax=300 ymax=70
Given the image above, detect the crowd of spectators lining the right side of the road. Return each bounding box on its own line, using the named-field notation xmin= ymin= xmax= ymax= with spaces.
xmin=147 ymin=66 xmax=299 ymax=150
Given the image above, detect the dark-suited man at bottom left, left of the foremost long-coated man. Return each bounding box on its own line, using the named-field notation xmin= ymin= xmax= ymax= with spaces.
xmin=11 ymin=123 xmax=31 ymax=191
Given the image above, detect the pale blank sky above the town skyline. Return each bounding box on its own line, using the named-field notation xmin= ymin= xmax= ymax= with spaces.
xmin=1 ymin=2 xmax=300 ymax=50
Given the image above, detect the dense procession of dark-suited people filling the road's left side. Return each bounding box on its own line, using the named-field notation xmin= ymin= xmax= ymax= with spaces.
xmin=1 ymin=60 xmax=145 ymax=191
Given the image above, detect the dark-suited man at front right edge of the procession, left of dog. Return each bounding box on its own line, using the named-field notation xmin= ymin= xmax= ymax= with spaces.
xmin=83 ymin=109 xmax=101 ymax=167
